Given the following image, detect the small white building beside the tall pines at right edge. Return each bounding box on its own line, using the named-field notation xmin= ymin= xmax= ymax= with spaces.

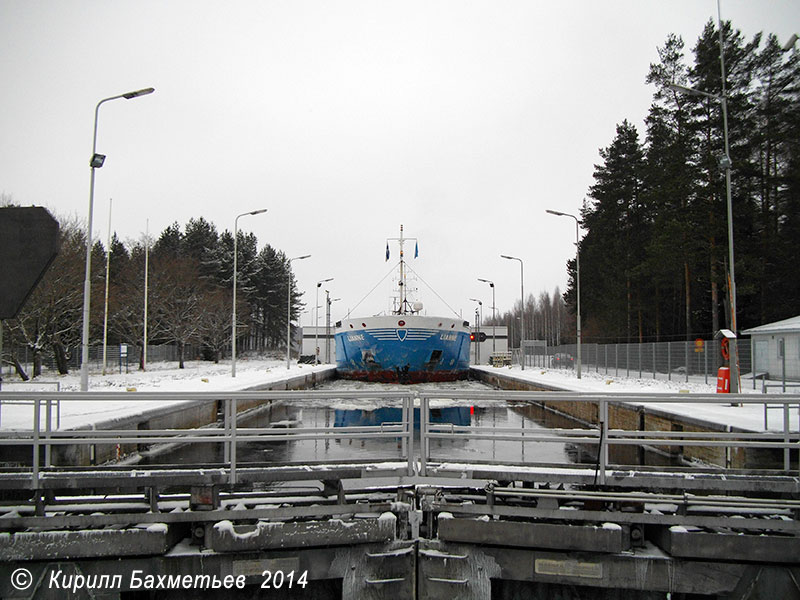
xmin=742 ymin=315 xmax=800 ymax=380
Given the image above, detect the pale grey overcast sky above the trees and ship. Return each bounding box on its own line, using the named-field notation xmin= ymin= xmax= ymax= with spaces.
xmin=0 ymin=0 xmax=800 ymax=324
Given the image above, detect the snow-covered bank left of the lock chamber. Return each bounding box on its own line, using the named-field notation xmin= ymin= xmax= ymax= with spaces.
xmin=0 ymin=358 xmax=330 ymax=430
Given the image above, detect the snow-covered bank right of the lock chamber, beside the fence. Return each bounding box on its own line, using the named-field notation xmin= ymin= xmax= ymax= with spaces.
xmin=475 ymin=366 xmax=800 ymax=431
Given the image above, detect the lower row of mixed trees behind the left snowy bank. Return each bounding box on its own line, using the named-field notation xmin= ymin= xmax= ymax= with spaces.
xmin=3 ymin=217 xmax=303 ymax=378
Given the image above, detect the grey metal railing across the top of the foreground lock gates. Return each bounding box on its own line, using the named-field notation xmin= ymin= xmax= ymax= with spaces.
xmin=0 ymin=388 xmax=800 ymax=489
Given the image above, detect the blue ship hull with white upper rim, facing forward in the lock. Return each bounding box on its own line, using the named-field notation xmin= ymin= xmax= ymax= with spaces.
xmin=334 ymin=315 xmax=470 ymax=383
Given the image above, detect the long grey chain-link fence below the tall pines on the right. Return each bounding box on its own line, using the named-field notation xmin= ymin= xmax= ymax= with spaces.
xmin=525 ymin=340 xmax=755 ymax=383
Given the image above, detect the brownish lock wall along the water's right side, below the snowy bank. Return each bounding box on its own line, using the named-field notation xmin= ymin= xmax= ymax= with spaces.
xmin=470 ymin=369 xmax=782 ymax=469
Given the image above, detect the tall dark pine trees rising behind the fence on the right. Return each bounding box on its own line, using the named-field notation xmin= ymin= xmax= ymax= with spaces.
xmin=564 ymin=21 xmax=800 ymax=341
